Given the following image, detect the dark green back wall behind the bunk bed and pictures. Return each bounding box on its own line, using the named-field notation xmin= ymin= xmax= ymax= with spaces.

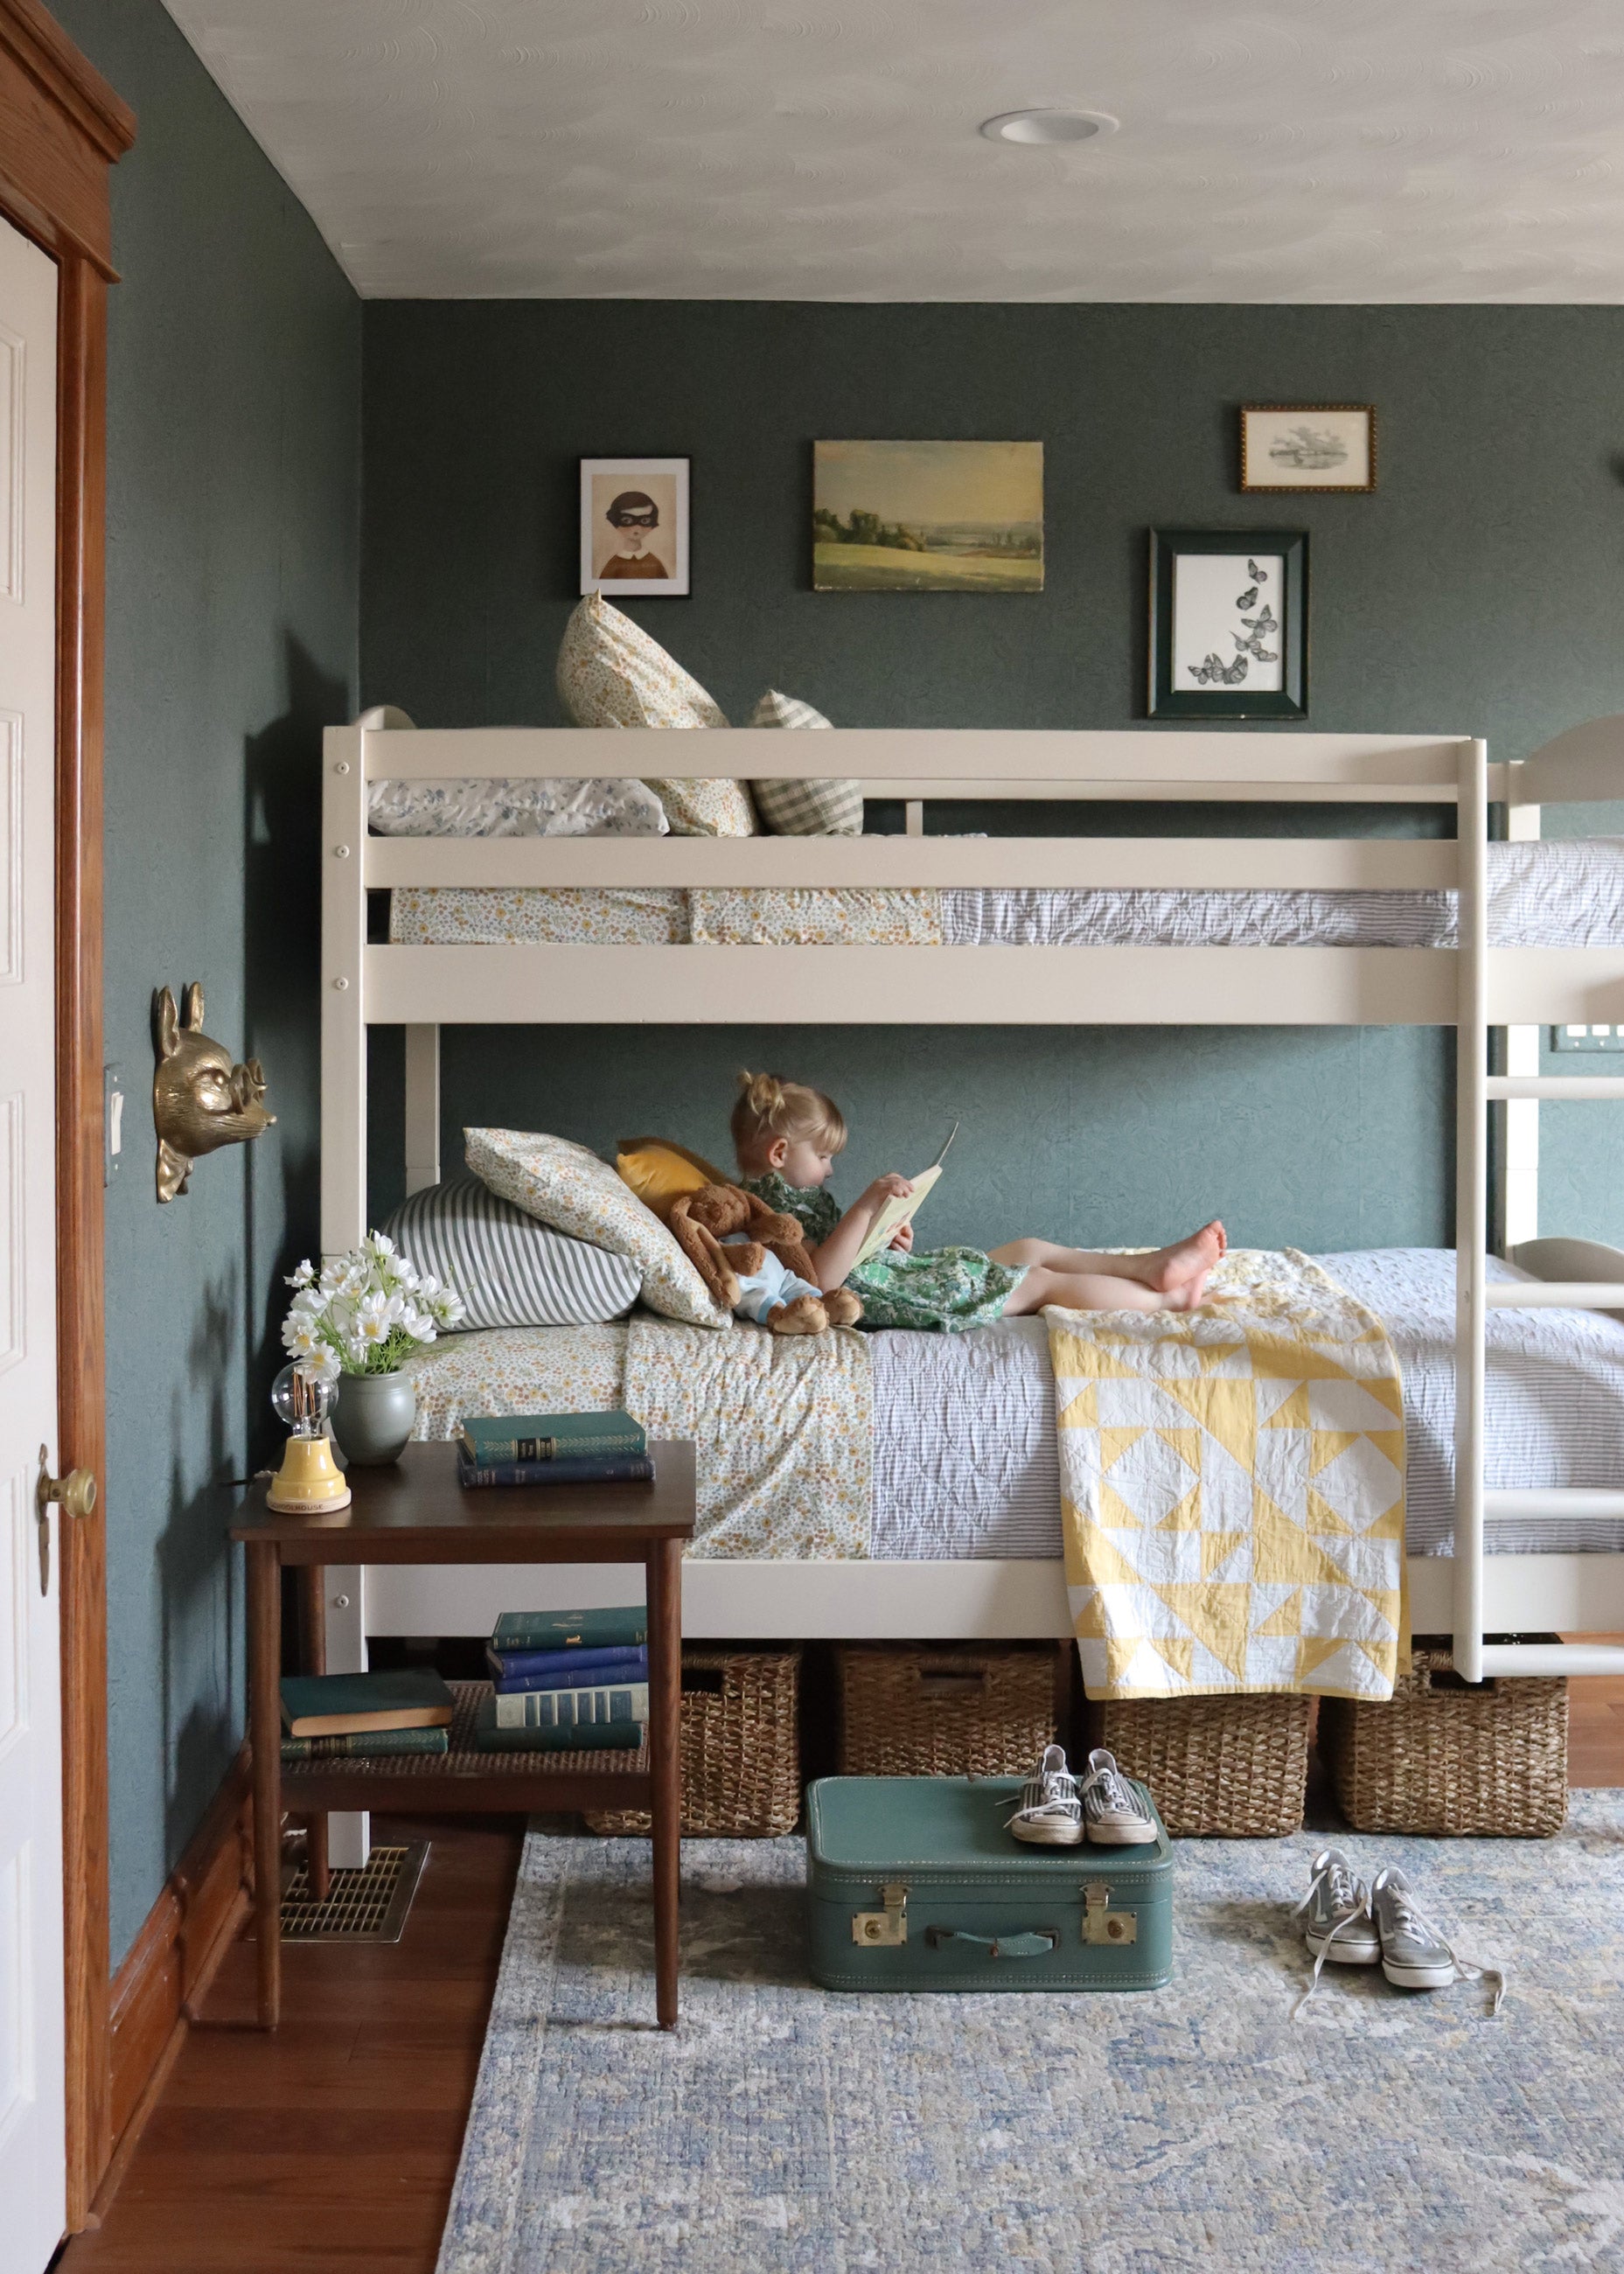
xmin=362 ymin=300 xmax=1624 ymax=1246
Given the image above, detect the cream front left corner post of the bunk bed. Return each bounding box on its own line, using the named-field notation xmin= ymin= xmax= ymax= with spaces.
xmin=321 ymin=725 xmax=371 ymax=1869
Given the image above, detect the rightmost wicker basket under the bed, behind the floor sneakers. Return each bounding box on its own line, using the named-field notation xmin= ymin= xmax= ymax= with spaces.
xmin=1319 ymin=1635 xmax=1567 ymax=1839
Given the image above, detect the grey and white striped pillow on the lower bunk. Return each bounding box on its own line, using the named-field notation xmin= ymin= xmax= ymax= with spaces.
xmin=385 ymin=1175 xmax=639 ymax=1328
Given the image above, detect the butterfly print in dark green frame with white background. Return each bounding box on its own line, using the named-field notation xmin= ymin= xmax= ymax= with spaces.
xmin=1148 ymin=530 xmax=1307 ymax=719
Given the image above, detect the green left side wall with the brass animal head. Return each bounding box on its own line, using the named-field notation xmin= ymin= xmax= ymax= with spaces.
xmin=54 ymin=0 xmax=359 ymax=1963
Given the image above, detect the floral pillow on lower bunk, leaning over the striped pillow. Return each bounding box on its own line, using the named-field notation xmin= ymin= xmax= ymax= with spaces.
xmin=462 ymin=1130 xmax=732 ymax=1326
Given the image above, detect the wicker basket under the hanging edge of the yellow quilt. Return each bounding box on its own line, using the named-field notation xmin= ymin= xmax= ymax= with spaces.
xmin=1090 ymin=1697 xmax=1314 ymax=1839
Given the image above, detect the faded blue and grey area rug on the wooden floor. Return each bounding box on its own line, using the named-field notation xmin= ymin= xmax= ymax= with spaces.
xmin=439 ymin=1792 xmax=1624 ymax=2274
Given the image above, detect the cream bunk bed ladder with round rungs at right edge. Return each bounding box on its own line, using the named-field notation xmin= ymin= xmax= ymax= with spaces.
xmin=1453 ymin=742 xmax=1624 ymax=1683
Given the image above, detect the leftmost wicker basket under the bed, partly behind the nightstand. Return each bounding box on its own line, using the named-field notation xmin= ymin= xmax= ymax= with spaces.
xmin=587 ymin=1651 xmax=800 ymax=1839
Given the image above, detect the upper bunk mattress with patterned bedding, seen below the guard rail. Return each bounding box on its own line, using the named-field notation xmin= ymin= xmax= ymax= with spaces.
xmin=389 ymin=837 xmax=1624 ymax=948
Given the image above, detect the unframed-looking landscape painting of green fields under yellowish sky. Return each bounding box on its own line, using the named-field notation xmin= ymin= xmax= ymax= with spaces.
xmin=812 ymin=441 xmax=1044 ymax=591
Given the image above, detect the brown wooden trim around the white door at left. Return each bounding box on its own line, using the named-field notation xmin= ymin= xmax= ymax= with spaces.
xmin=0 ymin=0 xmax=134 ymax=2233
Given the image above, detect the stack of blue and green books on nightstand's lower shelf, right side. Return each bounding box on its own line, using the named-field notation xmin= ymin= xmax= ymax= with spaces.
xmin=476 ymin=1603 xmax=648 ymax=1754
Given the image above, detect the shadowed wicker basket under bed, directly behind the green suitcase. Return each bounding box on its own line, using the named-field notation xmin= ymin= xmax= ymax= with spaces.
xmin=835 ymin=1642 xmax=1056 ymax=1776
